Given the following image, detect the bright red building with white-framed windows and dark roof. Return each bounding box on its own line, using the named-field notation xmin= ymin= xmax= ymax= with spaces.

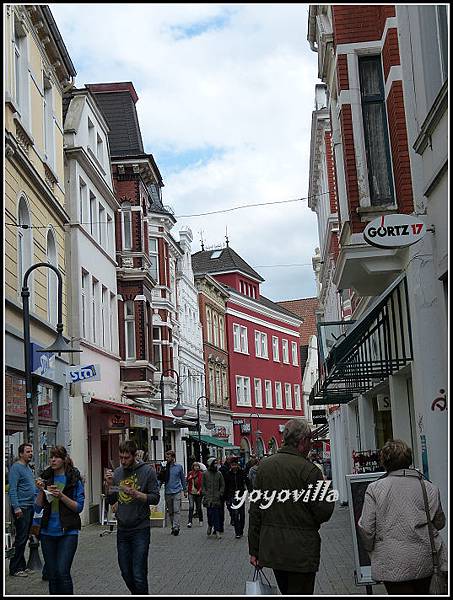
xmin=192 ymin=243 xmax=303 ymax=456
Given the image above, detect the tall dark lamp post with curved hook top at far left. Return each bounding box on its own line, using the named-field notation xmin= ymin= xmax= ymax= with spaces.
xmin=21 ymin=262 xmax=82 ymax=569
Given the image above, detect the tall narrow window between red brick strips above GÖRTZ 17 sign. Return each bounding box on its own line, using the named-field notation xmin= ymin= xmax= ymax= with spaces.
xmin=359 ymin=56 xmax=394 ymax=206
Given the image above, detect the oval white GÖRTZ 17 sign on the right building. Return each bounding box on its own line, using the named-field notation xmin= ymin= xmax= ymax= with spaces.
xmin=363 ymin=215 xmax=427 ymax=248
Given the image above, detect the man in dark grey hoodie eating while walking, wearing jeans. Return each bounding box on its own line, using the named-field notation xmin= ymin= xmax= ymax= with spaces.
xmin=104 ymin=440 xmax=160 ymax=595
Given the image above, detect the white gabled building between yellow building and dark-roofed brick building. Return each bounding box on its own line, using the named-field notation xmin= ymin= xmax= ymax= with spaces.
xmin=63 ymin=88 xmax=121 ymax=521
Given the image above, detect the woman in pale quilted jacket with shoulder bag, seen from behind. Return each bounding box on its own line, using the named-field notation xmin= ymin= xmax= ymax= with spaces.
xmin=358 ymin=440 xmax=446 ymax=595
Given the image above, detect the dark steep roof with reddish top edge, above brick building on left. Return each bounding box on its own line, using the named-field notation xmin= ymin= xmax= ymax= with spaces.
xmin=86 ymin=82 xmax=144 ymax=158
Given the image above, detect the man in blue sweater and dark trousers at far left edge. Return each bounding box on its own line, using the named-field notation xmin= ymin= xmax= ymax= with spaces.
xmin=8 ymin=442 xmax=37 ymax=577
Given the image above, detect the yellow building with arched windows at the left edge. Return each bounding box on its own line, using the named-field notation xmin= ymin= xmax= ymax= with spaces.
xmin=4 ymin=5 xmax=76 ymax=474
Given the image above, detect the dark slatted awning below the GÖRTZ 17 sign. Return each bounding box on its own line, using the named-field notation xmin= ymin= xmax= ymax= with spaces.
xmin=309 ymin=274 xmax=413 ymax=405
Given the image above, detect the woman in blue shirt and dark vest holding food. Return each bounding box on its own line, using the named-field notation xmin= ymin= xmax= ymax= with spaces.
xmin=36 ymin=446 xmax=85 ymax=595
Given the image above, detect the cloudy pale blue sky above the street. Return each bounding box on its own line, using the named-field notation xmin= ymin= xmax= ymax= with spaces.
xmin=49 ymin=4 xmax=318 ymax=301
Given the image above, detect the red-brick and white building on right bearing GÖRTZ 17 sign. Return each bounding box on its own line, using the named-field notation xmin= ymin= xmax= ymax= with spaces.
xmin=308 ymin=5 xmax=448 ymax=506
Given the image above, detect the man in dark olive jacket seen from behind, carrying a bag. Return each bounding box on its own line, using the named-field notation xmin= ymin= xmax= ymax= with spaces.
xmin=248 ymin=419 xmax=334 ymax=595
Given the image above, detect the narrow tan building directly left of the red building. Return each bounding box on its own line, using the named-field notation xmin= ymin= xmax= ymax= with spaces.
xmin=194 ymin=273 xmax=233 ymax=459
